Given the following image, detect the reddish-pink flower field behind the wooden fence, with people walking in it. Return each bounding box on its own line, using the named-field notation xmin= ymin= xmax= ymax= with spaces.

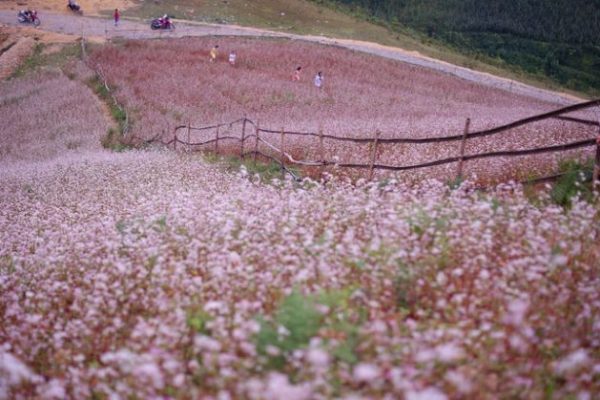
xmin=89 ymin=38 xmax=597 ymax=181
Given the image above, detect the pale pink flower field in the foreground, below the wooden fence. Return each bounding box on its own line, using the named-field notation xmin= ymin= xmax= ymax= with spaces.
xmin=0 ymin=152 xmax=600 ymax=399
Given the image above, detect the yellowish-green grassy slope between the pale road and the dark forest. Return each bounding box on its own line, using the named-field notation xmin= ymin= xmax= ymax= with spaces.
xmin=127 ymin=0 xmax=585 ymax=96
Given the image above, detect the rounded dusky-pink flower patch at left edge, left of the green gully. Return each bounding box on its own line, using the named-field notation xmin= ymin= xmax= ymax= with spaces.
xmin=0 ymin=71 xmax=108 ymax=163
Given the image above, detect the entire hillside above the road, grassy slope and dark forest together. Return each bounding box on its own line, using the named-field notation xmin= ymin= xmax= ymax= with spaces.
xmin=0 ymin=0 xmax=600 ymax=97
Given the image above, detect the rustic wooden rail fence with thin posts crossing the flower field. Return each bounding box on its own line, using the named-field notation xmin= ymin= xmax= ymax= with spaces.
xmin=146 ymin=99 xmax=600 ymax=182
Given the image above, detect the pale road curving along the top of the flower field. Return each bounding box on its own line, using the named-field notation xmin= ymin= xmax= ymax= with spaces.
xmin=0 ymin=10 xmax=583 ymax=104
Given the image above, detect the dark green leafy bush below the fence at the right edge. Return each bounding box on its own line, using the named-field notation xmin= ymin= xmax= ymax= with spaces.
xmin=551 ymin=159 xmax=594 ymax=207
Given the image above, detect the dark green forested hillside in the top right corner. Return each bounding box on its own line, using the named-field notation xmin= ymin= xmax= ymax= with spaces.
xmin=316 ymin=0 xmax=600 ymax=96
